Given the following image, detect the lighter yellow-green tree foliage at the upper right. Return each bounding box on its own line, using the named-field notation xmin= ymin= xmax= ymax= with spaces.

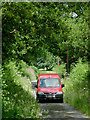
xmin=62 ymin=4 xmax=89 ymax=61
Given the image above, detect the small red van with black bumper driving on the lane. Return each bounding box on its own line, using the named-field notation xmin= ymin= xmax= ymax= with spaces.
xmin=36 ymin=74 xmax=64 ymax=103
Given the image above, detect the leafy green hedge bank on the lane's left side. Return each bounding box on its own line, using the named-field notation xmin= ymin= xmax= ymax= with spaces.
xmin=2 ymin=62 xmax=39 ymax=119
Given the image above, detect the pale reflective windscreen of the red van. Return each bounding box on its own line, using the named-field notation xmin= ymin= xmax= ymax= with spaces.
xmin=39 ymin=78 xmax=60 ymax=87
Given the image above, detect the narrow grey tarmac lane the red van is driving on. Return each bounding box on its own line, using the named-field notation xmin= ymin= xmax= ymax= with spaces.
xmin=32 ymin=80 xmax=89 ymax=120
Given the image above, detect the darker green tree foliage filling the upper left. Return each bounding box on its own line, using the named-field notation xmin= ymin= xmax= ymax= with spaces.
xmin=2 ymin=2 xmax=66 ymax=63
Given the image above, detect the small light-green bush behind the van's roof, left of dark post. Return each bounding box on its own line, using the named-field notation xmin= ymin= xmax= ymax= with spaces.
xmin=53 ymin=63 xmax=66 ymax=78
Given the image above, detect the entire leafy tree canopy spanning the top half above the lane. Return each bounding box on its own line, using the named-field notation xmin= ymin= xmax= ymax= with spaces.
xmin=2 ymin=2 xmax=89 ymax=62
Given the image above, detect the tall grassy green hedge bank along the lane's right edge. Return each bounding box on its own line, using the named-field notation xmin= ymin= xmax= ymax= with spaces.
xmin=64 ymin=59 xmax=89 ymax=115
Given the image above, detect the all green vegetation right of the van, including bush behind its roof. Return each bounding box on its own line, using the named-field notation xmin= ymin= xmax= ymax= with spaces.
xmin=51 ymin=58 xmax=90 ymax=116
